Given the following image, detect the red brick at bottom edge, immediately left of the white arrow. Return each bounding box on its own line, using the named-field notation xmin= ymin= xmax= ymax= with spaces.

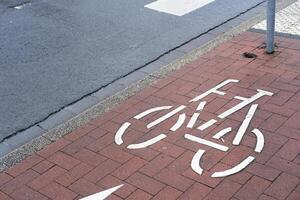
xmin=40 ymin=183 xmax=77 ymax=200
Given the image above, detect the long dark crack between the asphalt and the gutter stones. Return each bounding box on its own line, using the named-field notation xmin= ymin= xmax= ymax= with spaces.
xmin=0 ymin=0 xmax=266 ymax=143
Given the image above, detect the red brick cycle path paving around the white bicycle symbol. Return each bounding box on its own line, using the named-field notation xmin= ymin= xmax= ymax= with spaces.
xmin=0 ymin=32 xmax=300 ymax=200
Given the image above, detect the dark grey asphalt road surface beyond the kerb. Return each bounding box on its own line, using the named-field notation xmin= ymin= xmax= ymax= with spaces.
xmin=0 ymin=0 xmax=262 ymax=141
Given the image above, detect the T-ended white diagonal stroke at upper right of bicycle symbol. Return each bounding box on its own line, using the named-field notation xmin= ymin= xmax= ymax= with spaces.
xmin=218 ymin=89 xmax=273 ymax=119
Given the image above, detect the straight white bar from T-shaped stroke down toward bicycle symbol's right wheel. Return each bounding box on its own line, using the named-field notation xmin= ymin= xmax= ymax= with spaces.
xmin=232 ymin=104 xmax=258 ymax=145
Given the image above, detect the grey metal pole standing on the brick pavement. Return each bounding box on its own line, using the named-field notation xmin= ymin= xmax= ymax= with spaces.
xmin=267 ymin=0 xmax=275 ymax=54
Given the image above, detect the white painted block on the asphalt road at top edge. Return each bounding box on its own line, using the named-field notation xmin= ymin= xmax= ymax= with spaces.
xmin=145 ymin=0 xmax=215 ymax=16
